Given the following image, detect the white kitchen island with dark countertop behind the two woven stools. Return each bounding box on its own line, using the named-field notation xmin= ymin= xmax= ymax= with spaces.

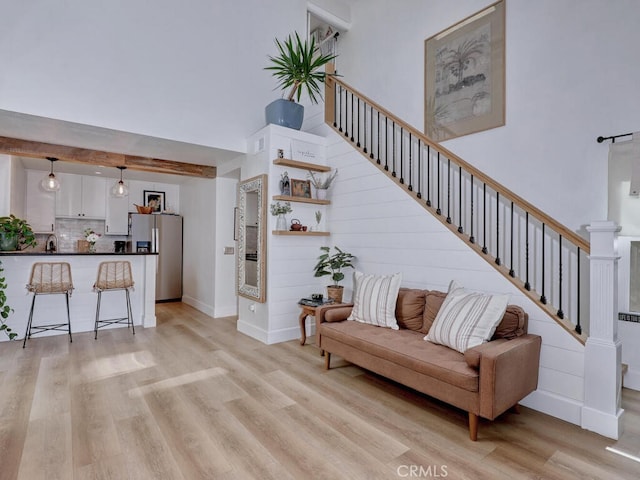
xmin=0 ymin=251 xmax=157 ymax=341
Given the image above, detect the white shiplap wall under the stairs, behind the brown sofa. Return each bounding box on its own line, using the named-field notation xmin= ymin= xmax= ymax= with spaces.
xmin=327 ymin=127 xmax=584 ymax=423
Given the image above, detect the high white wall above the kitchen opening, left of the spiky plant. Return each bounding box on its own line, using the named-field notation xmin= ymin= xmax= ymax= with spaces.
xmin=0 ymin=0 xmax=306 ymax=151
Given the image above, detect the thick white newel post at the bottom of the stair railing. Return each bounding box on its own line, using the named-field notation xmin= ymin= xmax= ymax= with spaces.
xmin=582 ymin=221 xmax=624 ymax=439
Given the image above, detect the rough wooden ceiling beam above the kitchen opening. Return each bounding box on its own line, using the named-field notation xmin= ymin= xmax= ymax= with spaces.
xmin=0 ymin=136 xmax=216 ymax=178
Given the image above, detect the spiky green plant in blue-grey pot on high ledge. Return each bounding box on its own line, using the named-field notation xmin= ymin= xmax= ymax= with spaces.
xmin=265 ymin=32 xmax=336 ymax=130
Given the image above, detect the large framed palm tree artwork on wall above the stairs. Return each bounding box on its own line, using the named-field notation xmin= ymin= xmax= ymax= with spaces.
xmin=424 ymin=0 xmax=505 ymax=142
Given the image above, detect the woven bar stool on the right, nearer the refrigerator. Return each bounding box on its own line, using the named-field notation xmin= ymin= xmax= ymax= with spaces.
xmin=93 ymin=261 xmax=136 ymax=339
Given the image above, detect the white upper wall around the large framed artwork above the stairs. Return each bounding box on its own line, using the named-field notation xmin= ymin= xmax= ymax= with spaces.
xmin=338 ymin=0 xmax=640 ymax=230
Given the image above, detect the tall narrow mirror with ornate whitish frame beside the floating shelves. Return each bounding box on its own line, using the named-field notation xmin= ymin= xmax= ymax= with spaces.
xmin=237 ymin=175 xmax=268 ymax=303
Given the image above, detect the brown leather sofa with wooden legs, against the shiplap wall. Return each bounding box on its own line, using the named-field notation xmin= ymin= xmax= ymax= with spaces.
xmin=316 ymin=288 xmax=542 ymax=441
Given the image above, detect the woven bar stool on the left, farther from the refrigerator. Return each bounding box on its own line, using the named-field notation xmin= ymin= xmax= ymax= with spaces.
xmin=22 ymin=262 xmax=73 ymax=348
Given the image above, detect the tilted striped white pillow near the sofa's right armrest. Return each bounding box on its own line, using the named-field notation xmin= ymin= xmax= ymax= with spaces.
xmin=424 ymin=281 xmax=509 ymax=353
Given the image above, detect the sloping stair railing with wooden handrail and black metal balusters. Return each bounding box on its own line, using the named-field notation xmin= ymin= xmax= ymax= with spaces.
xmin=325 ymin=71 xmax=590 ymax=344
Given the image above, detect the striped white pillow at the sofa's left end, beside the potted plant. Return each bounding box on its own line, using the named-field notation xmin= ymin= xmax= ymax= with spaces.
xmin=347 ymin=271 xmax=402 ymax=330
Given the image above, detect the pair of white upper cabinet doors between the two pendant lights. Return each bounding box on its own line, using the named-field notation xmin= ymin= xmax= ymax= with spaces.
xmin=56 ymin=173 xmax=107 ymax=220
